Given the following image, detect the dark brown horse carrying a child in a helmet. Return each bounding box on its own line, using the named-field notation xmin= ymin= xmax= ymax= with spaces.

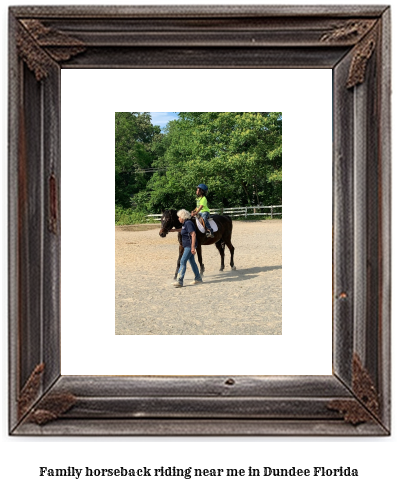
xmin=159 ymin=210 xmax=236 ymax=279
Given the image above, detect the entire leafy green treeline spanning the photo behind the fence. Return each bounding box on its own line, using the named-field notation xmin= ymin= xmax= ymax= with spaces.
xmin=115 ymin=112 xmax=282 ymax=221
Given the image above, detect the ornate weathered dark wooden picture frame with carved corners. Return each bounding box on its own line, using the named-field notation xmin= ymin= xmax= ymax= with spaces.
xmin=9 ymin=5 xmax=391 ymax=436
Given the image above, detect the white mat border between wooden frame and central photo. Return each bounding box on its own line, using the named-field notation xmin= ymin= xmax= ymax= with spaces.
xmin=61 ymin=70 xmax=332 ymax=375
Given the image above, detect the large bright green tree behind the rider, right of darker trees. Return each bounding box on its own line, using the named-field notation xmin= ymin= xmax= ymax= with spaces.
xmin=139 ymin=112 xmax=282 ymax=211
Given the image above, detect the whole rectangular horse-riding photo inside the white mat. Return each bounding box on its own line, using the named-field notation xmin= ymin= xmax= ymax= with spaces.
xmin=115 ymin=112 xmax=283 ymax=335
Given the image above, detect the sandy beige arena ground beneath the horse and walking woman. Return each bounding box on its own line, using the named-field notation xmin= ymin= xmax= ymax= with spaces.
xmin=115 ymin=220 xmax=282 ymax=335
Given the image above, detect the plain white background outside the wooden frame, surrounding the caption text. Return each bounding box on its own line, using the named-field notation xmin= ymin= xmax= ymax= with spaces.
xmin=0 ymin=0 xmax=399 ymax=492
